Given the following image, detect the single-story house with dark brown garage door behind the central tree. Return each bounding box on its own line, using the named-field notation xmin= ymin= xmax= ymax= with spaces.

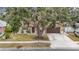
xmin=18 ymin=22 xmax=61 ymax=35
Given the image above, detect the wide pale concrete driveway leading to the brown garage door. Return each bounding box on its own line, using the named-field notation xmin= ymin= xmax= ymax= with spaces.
xmin=48 ymin=33 xmax=79 ymax=49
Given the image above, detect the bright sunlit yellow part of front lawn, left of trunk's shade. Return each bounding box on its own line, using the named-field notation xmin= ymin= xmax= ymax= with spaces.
xmin=11 ymin=34 xmax=34 ymax=41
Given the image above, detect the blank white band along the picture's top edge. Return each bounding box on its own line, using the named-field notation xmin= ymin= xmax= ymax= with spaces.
xmin=0 ymin=0 xmax=79 ymax=7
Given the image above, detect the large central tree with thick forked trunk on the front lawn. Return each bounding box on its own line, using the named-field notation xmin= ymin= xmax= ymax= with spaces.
xmin=26 ymin=7 xmax=55 ymax=38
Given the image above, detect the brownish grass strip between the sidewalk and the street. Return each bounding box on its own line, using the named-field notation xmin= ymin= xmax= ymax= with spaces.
xmin=0 ymin=43 xmax=50 ymax=48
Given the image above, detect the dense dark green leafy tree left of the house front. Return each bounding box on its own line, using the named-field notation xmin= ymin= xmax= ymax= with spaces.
xmin=3 ymin=7 xmax=29 ymax=33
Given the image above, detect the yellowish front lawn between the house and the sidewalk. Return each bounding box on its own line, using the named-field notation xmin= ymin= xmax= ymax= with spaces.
xmin=6 ymin=34 xmax=49 ymax=41
